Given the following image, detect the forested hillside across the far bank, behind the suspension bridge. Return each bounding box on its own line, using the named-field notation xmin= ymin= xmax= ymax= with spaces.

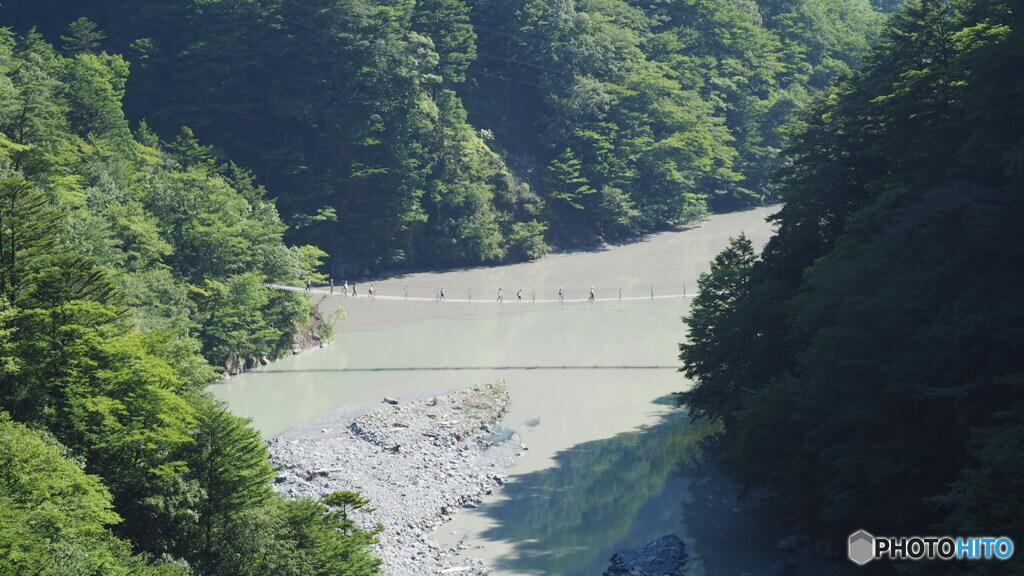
xmin=0 ymin=0 xmax=895 ymax=266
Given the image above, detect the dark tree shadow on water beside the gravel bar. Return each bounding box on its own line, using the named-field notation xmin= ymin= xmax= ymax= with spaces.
xmin=480 ymin=407 xmax=851 ymax=576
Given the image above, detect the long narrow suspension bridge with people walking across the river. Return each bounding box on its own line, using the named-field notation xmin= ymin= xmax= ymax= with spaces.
xmin=263 ymin=284 xmax=695 ymax=305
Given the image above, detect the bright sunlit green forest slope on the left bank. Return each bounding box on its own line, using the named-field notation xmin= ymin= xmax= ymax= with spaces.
xmin=0 ymin=29 xmax=380 ymax=576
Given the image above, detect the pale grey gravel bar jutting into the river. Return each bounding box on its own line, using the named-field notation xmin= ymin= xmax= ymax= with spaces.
xmin=268 ymin=382 xmax=525 ymax=576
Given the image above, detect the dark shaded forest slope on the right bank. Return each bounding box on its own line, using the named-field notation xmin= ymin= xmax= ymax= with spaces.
xmin=681 ymin=0 xmax=1024 ymax=575
